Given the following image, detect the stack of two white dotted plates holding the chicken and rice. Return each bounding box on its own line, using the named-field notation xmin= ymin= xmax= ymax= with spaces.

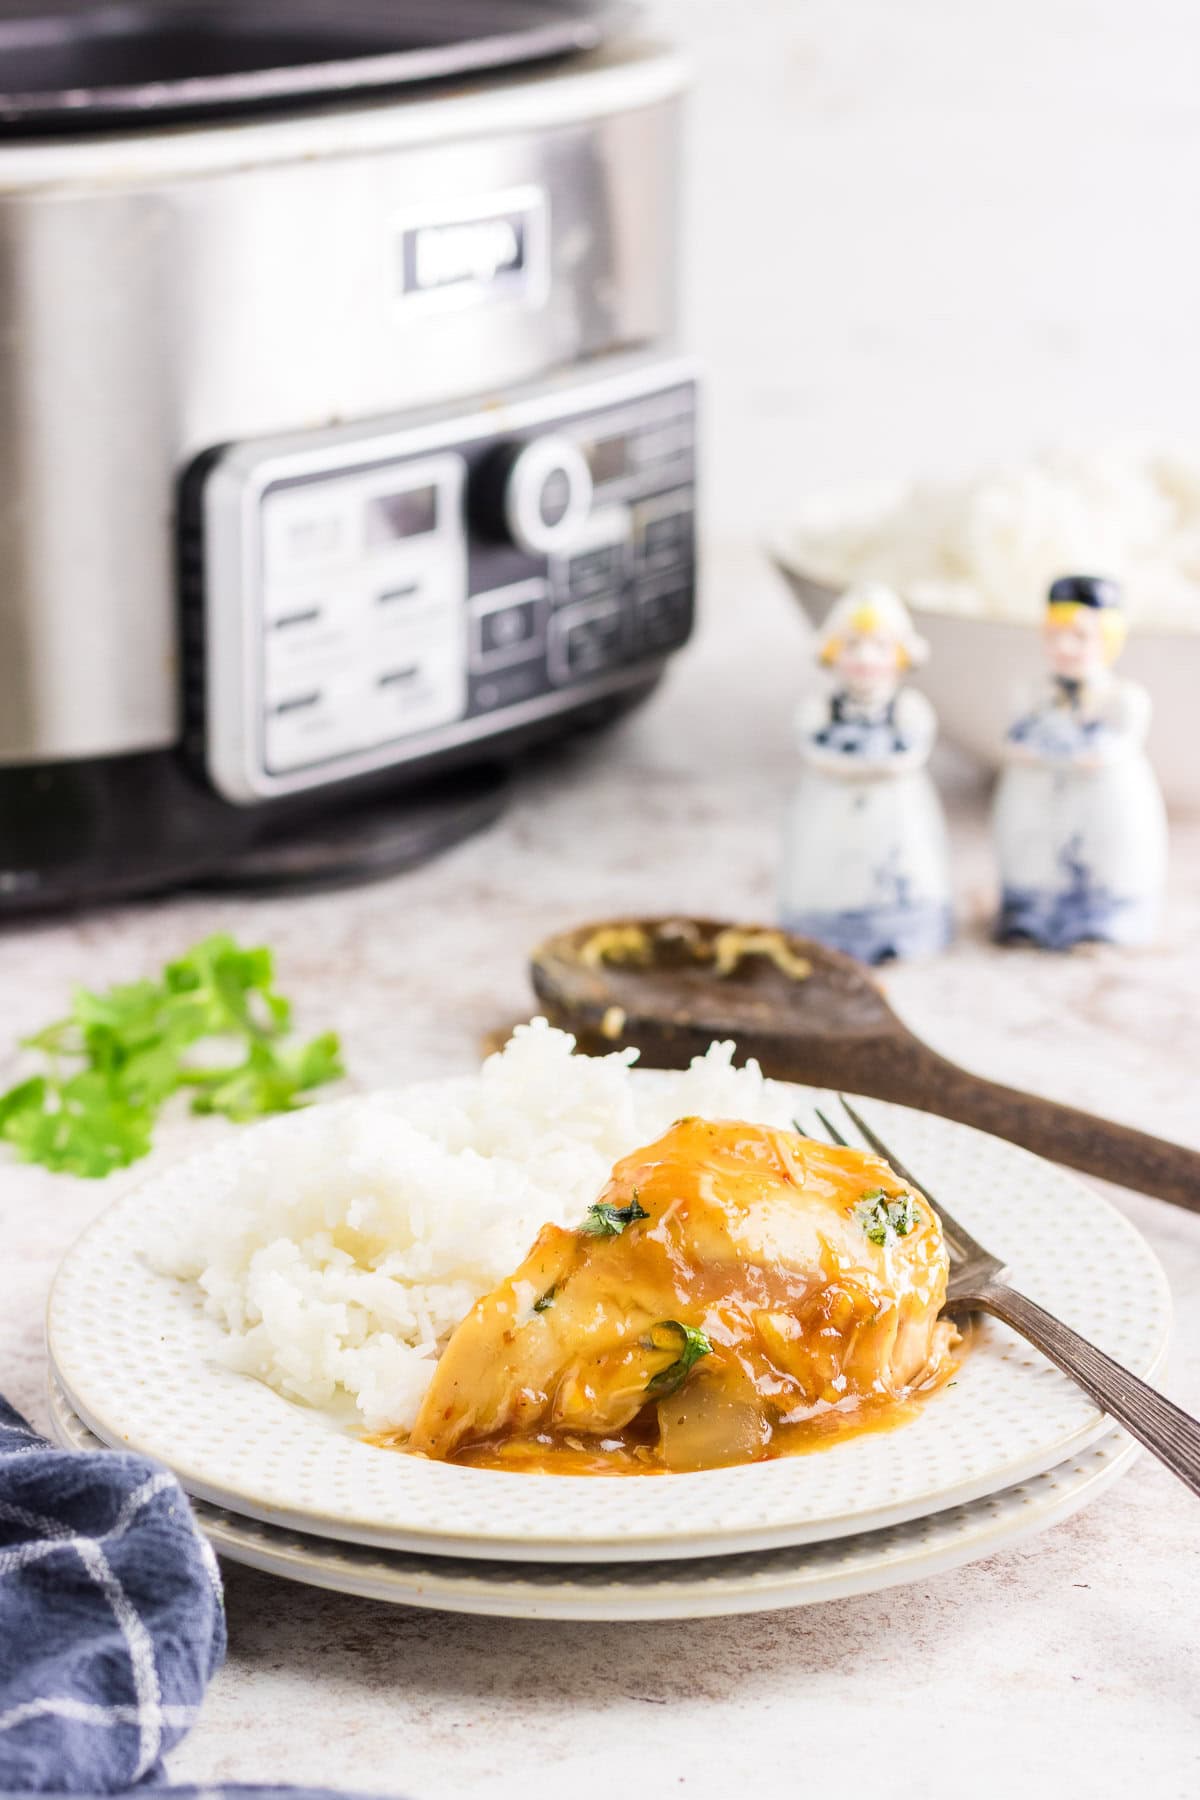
xmin=49 ymin=1075 xmax=1169 ymax=1618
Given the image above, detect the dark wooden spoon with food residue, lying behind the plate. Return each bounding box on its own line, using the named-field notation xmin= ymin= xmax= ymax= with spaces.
xmin=531 ymin=918 xmax=1200 ymax=1211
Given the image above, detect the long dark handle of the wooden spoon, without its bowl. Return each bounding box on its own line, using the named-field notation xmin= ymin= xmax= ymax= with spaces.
xmin=899 ymin=1046 xmax=1200 ymax=1213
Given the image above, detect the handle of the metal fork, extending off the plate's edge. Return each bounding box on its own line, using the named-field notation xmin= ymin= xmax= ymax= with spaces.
xmin=970 ymin=1282 xmax=1200 ymax=1494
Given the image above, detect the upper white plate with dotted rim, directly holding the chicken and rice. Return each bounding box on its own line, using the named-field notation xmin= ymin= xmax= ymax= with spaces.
xmin=49 ymin=1073 xmax=1169 ymax=1562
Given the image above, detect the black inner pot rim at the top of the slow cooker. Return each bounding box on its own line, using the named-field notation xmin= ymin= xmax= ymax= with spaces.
xmin=0 ymin=0 xmax=630 ymax=133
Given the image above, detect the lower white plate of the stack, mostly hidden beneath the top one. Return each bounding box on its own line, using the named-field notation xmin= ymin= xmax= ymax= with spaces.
xmin=50 ymin=1384 xmax=1139 ymax=1620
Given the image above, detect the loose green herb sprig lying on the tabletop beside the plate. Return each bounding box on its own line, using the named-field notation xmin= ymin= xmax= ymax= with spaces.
xmin=0 ymin=932 xmax=344 ymax=1177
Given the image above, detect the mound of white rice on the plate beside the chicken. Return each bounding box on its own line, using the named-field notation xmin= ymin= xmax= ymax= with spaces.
xmin=157 ymin=1019 xmax=790 ymax=1429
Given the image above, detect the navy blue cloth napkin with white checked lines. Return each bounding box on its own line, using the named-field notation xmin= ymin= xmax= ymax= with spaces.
xmin=0 ymin=1399 xmax=232 ymax=1796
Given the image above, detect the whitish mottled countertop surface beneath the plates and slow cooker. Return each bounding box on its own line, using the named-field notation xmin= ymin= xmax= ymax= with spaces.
xmin=0 ymin=547 xmax=1200 ymax=1800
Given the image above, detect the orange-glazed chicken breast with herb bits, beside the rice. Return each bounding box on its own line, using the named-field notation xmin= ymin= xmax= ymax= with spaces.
xmin=408 ymin=1118 xmax=955 ymax=1469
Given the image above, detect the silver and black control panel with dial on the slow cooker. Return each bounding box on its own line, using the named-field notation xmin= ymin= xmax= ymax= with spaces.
xmin=184 ymin=360 xmax=694 ymax=805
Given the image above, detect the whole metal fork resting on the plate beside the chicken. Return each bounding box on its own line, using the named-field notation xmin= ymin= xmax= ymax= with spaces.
xmin=813 ymin=1094 xmax=1200 ymax=1494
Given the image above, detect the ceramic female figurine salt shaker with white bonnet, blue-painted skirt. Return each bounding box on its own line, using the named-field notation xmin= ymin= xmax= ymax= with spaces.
xmin=781 ymin=583 xmax=954 ymax=963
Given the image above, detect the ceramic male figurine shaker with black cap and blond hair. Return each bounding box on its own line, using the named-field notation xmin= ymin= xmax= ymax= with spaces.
xmin=993 ymin=574 xmax=1166 ymax=950
